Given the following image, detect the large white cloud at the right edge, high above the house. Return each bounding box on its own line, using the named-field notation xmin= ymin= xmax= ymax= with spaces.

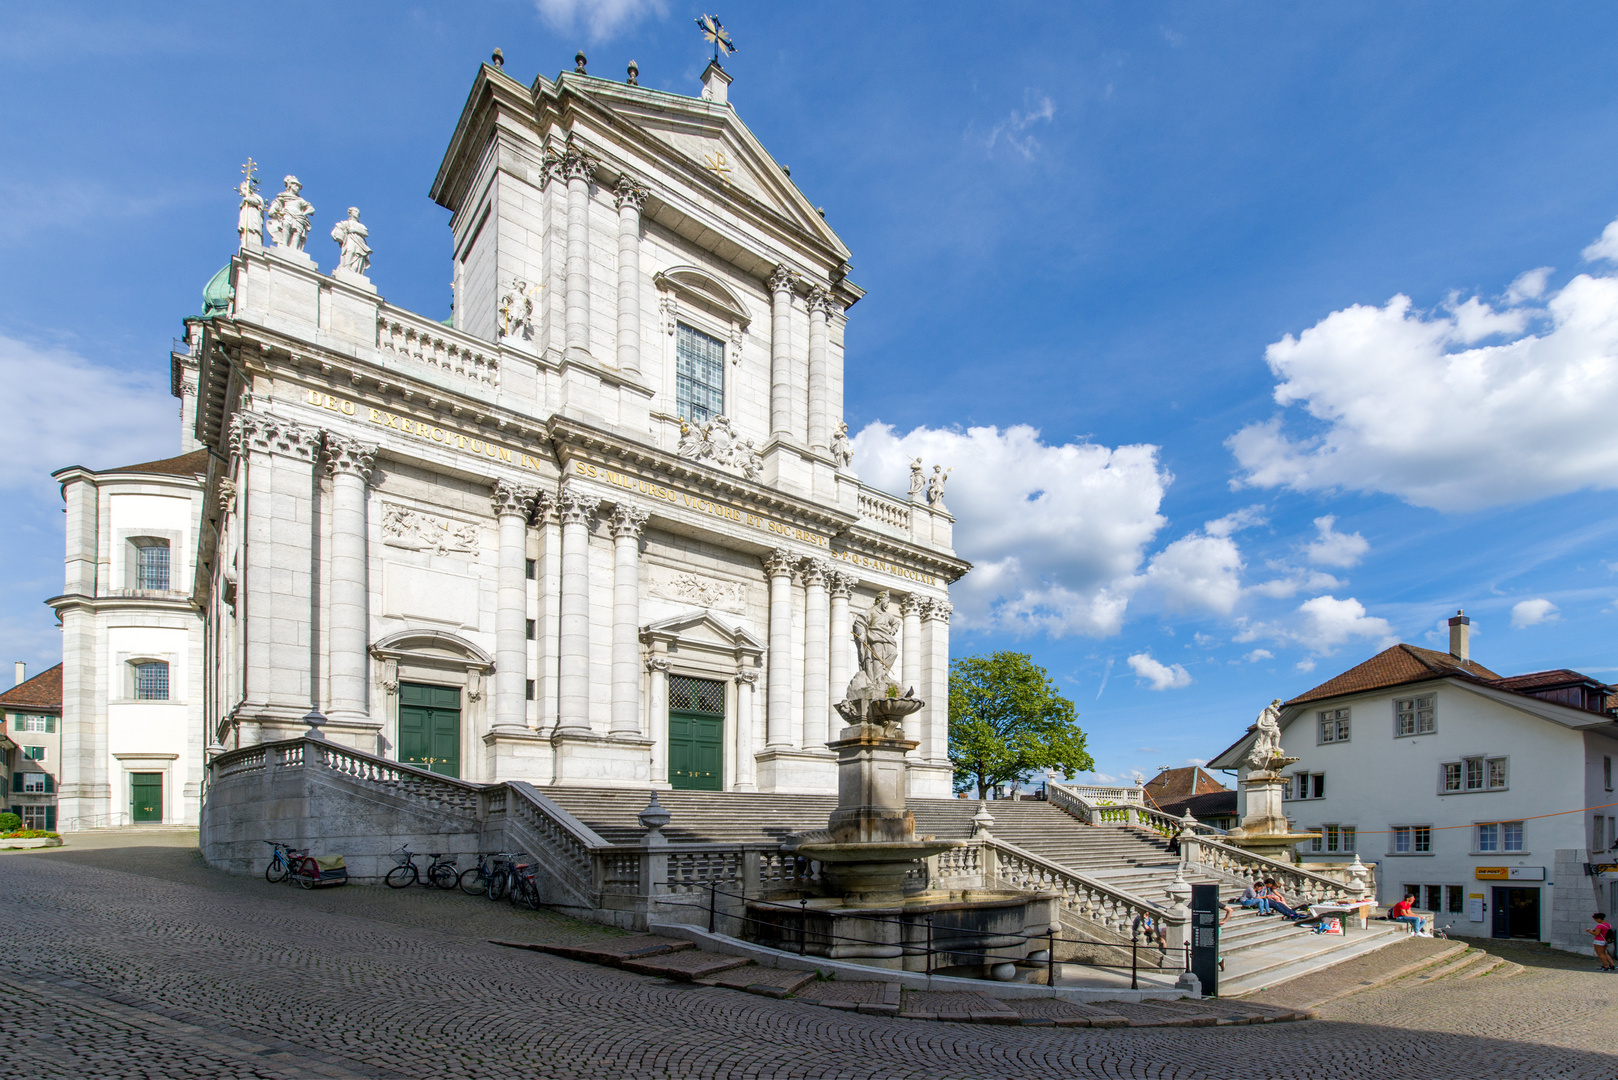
xmin=1226 ymin=222 xmax=1618 ymax=510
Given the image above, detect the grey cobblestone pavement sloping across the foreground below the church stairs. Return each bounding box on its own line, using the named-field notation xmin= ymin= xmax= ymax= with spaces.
xmin=0 ymin=845 xmax=1618 ymax=1080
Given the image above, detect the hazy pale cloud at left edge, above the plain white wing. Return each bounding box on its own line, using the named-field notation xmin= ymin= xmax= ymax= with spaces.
xmin=0 ymin=337 xmax=180 ymax=494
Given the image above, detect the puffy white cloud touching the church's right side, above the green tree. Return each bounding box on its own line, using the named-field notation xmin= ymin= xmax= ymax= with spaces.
xmin=854 ymin=421 xmax=1173 ymax=636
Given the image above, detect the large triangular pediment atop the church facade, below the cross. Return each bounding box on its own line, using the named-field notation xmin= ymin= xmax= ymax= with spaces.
xmin=563 ymin=76 xmax=848 ymax=257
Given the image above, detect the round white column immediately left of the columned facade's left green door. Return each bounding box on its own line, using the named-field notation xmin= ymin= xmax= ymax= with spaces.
xmin=325 ymin=432 xmax=377 ymax=722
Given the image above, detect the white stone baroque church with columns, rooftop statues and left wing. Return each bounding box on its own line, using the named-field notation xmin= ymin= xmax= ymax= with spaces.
xmin=49 ymin=53 xmax=969 ymax=827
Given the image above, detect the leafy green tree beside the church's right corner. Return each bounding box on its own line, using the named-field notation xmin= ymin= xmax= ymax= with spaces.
xmin=950 ymin=653 xmax=1095 ymax=798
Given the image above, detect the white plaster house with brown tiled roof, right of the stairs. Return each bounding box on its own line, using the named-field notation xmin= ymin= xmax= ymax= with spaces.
xmin=1209 ymin=614 xmax=1618 ymax=950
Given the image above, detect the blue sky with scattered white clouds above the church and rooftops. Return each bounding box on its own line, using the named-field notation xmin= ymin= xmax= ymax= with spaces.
xmin=0 ymin=0 xmax=1618 ymax=790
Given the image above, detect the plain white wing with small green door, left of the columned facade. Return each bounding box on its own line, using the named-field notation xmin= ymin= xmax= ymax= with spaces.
xmin=47 ymin=453 xmax=209 ymax=829
